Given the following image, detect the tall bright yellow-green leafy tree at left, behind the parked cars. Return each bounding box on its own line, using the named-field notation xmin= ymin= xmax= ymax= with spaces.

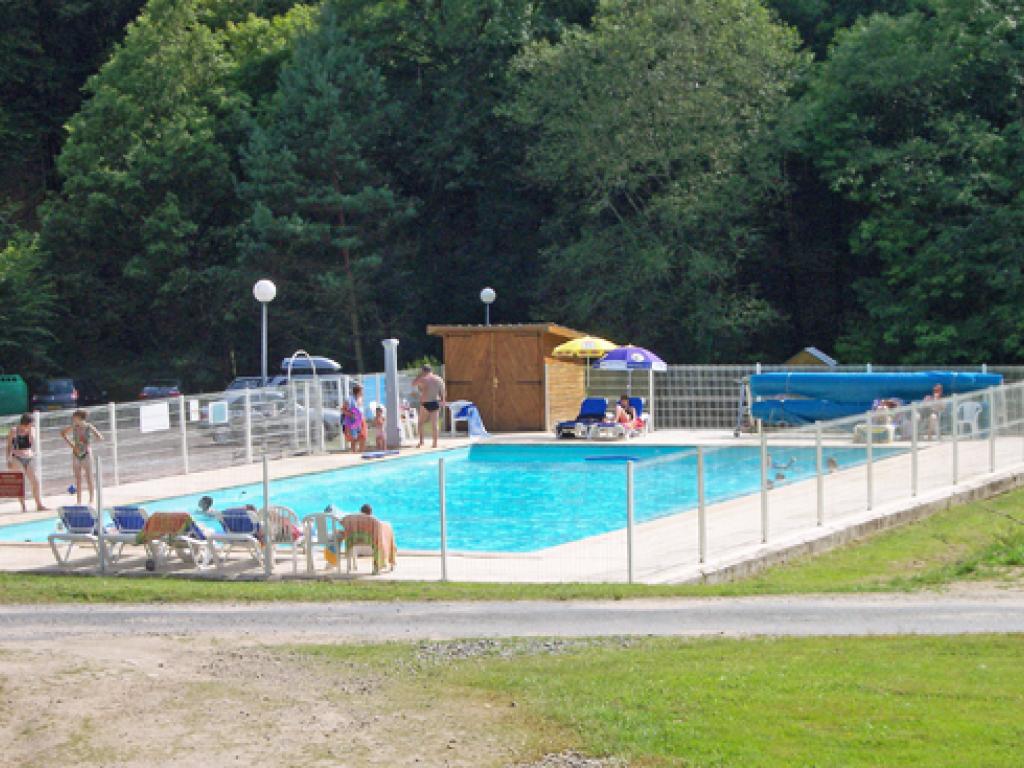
xmin=41 ymin=0 xmax=308 ymax=386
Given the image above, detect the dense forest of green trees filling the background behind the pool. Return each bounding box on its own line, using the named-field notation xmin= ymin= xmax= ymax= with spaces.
xmin=0 ymin=0 xmax=1024 ymax=392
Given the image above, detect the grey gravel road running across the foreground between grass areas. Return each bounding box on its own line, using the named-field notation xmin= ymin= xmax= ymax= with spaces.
xmin=0 ymin=591 xmax=1024 ymax=642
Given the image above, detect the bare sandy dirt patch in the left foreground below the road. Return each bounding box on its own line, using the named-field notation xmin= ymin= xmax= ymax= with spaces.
xmin=0 ymin=637 xmax=561 ymax=768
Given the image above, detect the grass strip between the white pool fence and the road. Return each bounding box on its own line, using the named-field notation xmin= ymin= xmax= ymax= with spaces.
xmin=0 ymin=490 xmax=1024 ymax=603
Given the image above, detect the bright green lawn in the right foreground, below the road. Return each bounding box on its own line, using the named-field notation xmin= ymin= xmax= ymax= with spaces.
xmin=307 ymin=636 xmax=1024 ymax=768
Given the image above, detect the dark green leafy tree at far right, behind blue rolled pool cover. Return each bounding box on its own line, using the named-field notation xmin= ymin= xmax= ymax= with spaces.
xmin=799 ymin=0 xmax=1024 ymax=362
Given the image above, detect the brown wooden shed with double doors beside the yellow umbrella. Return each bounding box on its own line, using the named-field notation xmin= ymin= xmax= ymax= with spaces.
xmin=427 ymin=323 xmax=585 ymax=432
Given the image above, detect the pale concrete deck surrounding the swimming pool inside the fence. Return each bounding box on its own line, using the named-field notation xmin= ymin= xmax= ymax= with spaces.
xmin=0 ymin=430 xmax=1024 ymax=584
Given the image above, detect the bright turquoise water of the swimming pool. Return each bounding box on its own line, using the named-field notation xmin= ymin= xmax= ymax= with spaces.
xmin=0 ymin=443 xmax=897 ymax=552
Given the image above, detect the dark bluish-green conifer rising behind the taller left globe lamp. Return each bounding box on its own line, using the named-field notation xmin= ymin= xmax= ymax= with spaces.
xmin=243 ymin=5 xmax=412 ymax=372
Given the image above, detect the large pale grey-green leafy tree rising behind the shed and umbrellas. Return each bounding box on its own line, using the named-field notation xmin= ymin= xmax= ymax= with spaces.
xmin=508 ymin=0 xmax=799 ymax=359
